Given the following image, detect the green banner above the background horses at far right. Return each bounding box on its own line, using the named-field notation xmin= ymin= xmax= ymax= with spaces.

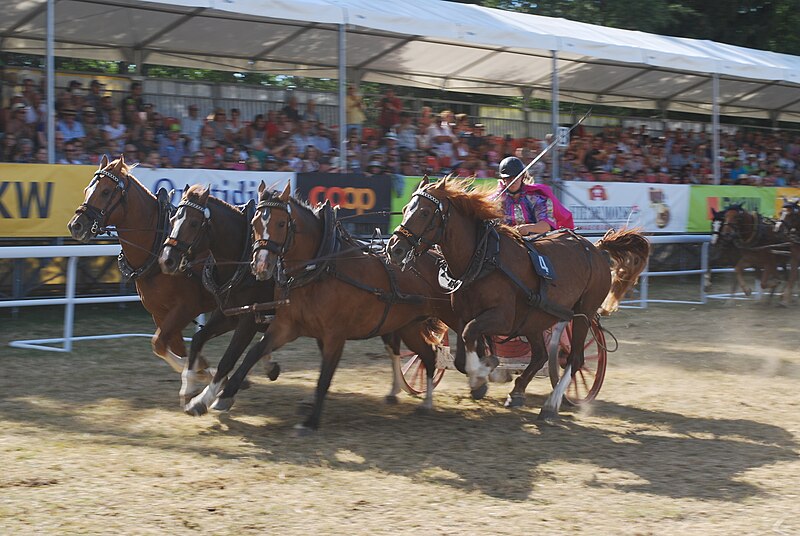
xmin=687 ymin=185 xmax=777 ymax=233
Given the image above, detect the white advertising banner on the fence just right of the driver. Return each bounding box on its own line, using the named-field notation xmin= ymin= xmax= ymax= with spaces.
xmin=560 ymin=182 xmax=690 ymax=233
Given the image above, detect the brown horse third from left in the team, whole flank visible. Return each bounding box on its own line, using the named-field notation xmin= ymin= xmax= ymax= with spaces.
xmin=189 ymin=183 xmax=462 ymax=432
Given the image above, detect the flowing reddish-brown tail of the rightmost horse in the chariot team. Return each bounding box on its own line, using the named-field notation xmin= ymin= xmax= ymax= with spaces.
xmin=596 ymin=229 xmax=650 ymax=315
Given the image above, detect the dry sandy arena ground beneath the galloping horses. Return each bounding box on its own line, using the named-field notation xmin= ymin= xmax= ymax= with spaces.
xmin=0 ymin=282 xmax=800 ymax=535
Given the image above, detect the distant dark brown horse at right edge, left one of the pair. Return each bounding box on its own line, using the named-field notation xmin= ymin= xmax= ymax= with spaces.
xmin=711 ymin=204 xmax=781 ymax=297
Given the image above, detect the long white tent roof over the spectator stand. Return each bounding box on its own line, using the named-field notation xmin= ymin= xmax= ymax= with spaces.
xmin=0 ymin=0 xmax=800 ymax=121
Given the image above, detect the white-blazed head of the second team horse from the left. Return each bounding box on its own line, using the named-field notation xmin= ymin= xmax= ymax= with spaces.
xmin=158 ymin=184 xmax=211 ymax=275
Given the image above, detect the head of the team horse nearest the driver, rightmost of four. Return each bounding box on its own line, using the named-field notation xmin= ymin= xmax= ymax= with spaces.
xmin=386 ymin=175 xmax=450 ymax=268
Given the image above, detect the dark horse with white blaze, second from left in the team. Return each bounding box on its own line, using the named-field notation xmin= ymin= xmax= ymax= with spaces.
xmin=159 ymin=185 xmax=280 ymax=408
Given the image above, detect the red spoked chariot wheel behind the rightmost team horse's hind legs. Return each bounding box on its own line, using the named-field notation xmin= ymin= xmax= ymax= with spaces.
xmin=548 ymin=319 xmax=608 ymax=406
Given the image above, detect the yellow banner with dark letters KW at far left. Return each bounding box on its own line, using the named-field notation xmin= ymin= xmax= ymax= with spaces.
xmin=0 ymin=164 xmax=95 ymax=238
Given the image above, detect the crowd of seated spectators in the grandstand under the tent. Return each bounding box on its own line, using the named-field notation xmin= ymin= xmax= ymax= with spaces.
xmin=0 ymin=79 xmax=800 ymax=186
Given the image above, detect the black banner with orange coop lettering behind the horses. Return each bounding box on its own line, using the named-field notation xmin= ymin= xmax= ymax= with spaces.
xmin=296 ymin=173 xmax=392 ymax=234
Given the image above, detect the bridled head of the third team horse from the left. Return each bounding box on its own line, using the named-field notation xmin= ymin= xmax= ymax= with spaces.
xmin=250 ymin=181 xmax=295 ymax=281
